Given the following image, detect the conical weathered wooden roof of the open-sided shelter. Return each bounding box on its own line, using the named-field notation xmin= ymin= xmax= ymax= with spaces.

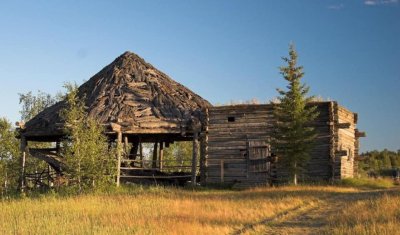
xmin=21 ymin=52 xmax=211 ymax=139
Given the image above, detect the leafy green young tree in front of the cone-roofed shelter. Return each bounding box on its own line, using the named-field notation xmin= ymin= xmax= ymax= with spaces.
xmin=61 ymin=84 xmax=116 ymax=192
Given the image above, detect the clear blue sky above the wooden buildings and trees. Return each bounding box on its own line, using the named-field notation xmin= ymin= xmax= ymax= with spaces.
xmin=0 ymin=0 xmax=400 ymax=151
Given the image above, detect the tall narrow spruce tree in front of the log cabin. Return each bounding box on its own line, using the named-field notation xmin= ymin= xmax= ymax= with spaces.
xmin=272 ymin=45 xmax=318 ymax=184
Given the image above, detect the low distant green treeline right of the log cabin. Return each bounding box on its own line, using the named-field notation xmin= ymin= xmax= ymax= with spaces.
xmin=359 ymin=149 xmax=400 ymax=176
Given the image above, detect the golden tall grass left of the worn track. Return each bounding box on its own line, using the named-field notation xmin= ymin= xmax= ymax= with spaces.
xmin=0 ymin=187 xmax=340 ymax=234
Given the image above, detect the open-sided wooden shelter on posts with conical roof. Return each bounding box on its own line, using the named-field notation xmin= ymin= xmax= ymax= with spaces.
xmin=20 ymin=52 xmax=211 ymax=188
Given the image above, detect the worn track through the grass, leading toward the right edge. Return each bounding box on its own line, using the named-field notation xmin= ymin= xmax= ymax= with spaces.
xmin=233 ymin=188 xmax=400 ymax=235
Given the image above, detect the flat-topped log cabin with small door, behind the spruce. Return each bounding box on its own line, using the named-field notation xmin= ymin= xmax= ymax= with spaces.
xmin=205 ymin=101 xmax=365 ymax=187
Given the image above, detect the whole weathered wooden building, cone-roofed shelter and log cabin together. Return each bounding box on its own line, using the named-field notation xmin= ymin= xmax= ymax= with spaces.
xmin=19 ymin=52 xmax=363 ymax=189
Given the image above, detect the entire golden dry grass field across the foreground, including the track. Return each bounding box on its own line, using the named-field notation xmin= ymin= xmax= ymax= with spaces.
xmin=0 ymin=183 xmax=400 ymax=234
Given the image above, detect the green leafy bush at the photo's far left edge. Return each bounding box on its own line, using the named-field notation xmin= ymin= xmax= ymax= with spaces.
xmin=0 ymin=118 xmax=19 ymax=195
